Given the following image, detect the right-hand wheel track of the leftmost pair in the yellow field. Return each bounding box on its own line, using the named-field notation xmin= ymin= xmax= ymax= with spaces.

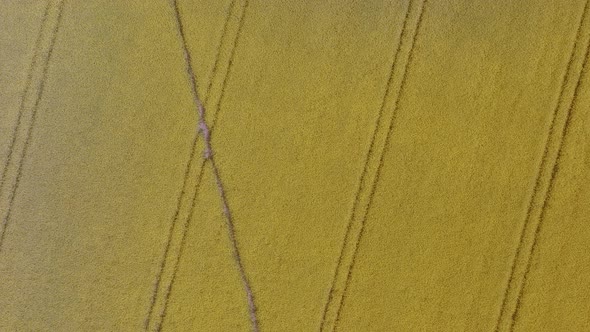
xmin=0 ymin=1 xmax=64 ymax=252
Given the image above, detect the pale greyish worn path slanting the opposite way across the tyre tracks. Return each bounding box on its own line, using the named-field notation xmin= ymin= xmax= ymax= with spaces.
xmin=158 ymin=0 xmax=259 ymax=332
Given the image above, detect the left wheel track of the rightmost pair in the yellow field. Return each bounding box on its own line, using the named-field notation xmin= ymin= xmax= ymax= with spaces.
xmin=494 ymin=1 xmax=589 ymax=332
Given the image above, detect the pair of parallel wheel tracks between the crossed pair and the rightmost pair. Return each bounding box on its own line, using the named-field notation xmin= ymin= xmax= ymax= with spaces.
xmin=320 ymin=0 xmax=428 ymax=330
